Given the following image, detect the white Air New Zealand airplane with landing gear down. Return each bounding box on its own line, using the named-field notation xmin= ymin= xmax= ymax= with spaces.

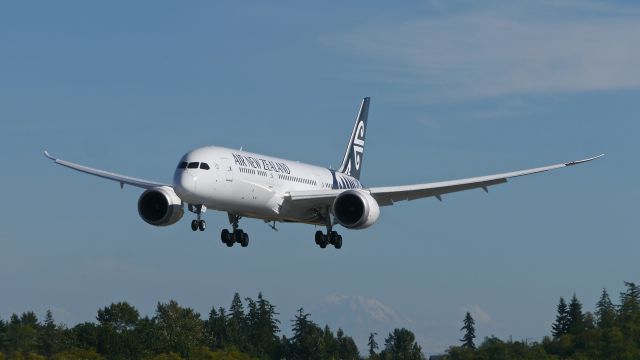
xmin=44 ymin=97 xmax=604 ymax=249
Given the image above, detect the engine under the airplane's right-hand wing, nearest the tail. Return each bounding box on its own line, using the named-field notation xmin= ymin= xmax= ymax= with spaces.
xmin=331 ymin=190 xmax=380 ymax=229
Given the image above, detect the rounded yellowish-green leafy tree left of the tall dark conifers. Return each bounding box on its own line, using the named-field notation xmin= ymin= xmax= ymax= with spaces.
xmin=154 ymin=300 xmax=204 ymax=358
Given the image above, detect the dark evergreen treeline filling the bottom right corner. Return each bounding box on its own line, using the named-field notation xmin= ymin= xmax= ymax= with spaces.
xmin=445 ymin=282 xmax=640 ymax=360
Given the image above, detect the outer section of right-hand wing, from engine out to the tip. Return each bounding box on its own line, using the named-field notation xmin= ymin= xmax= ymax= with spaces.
xmin=369 ymin=154 xmax=604 ymax=206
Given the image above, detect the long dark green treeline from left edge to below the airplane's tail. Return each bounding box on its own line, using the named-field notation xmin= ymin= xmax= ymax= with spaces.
xmin=0 ymin=294 xmax=424 ymax=360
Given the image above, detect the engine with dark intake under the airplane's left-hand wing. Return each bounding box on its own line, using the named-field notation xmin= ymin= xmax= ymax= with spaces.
xmin=138 ymin=186 xmax=184 ymax=226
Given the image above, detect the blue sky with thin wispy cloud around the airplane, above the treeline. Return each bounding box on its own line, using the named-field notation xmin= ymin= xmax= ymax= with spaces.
xmin=0 ymin=1 xmax=640 ymax=353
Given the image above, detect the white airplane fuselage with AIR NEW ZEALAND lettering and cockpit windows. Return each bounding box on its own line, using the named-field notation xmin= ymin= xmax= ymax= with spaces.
xmin=173 ymin=146 xmax=362 ymax=225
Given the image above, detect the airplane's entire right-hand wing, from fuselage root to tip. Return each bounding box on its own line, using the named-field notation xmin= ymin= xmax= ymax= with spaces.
xmin=285 ymin=154 xmax=604 ymax=206
